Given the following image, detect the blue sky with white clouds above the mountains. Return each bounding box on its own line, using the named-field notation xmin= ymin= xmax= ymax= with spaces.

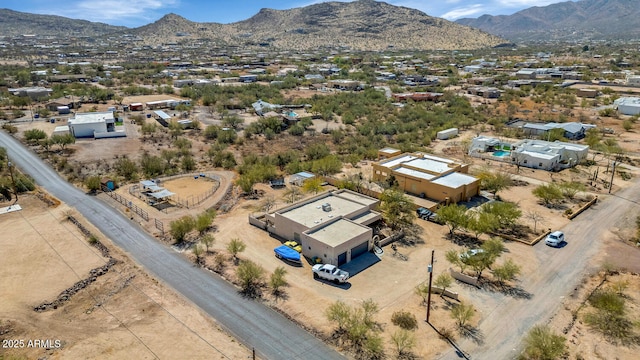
xmin=0 ymin=0 xmax=576 ymax=27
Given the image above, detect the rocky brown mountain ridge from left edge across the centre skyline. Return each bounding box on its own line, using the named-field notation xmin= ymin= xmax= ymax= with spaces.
xmin=0 ymin=0 xmax=506 ymax=51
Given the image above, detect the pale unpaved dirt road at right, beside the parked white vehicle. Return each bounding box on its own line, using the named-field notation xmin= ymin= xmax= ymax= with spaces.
xmin=439 ymin=179 xmax=640 ymax=359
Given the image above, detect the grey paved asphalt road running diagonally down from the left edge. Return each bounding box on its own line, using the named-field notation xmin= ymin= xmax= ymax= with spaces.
xmin=0 ymin=131 xmax=344 ymax=360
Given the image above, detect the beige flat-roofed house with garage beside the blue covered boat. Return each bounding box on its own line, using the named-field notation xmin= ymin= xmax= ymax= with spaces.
xmin=265 ymin=189 xmax=382 ymax=266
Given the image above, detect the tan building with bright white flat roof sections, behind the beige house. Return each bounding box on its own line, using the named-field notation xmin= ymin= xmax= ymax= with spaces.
xmin=373 ymin=148 xmax=480 ymax=203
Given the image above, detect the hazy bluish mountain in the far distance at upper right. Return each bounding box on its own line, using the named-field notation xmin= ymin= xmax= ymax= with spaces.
xmin=456 ymin=0 xmax=640 ymax=41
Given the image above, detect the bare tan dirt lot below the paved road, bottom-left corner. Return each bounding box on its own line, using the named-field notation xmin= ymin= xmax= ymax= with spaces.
xmin=0 ymin=195 xmax=251 ymax=359
